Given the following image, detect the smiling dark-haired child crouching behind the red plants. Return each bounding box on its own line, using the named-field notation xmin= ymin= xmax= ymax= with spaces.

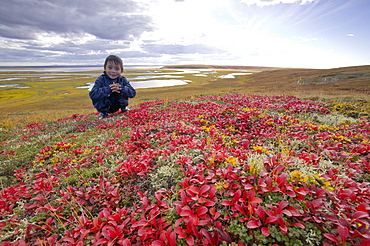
xmin=89 ymin=55 xmax=136 ymax=119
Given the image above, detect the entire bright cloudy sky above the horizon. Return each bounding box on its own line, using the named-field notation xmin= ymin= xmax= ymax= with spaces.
xmin=0 ymin=0 xmax=370 ymax=68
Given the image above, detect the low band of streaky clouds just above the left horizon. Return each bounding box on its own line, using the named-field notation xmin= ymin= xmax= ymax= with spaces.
xmin=0 ymin=36 xmax=133 ymax=65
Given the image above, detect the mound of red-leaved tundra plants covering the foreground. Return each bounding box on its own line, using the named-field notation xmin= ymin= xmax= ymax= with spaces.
xmin=0 ymin=94 xmax=370 ymax=246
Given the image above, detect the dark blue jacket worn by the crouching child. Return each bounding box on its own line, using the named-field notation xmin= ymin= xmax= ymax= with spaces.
xmin=89 ymin=72 xmax=136 ymax=113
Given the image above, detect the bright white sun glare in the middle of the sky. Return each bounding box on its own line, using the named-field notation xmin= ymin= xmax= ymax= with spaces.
xmin=137 ymin=0 xmax=366 ymax=68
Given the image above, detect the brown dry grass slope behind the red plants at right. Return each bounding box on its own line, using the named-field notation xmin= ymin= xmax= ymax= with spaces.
xmin=141 ymin=66 xmax=370 ymax=101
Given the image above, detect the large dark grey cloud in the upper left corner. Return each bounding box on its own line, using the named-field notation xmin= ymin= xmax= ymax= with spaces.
xmin=0 ymin=0 xmax=153 ymax=40
